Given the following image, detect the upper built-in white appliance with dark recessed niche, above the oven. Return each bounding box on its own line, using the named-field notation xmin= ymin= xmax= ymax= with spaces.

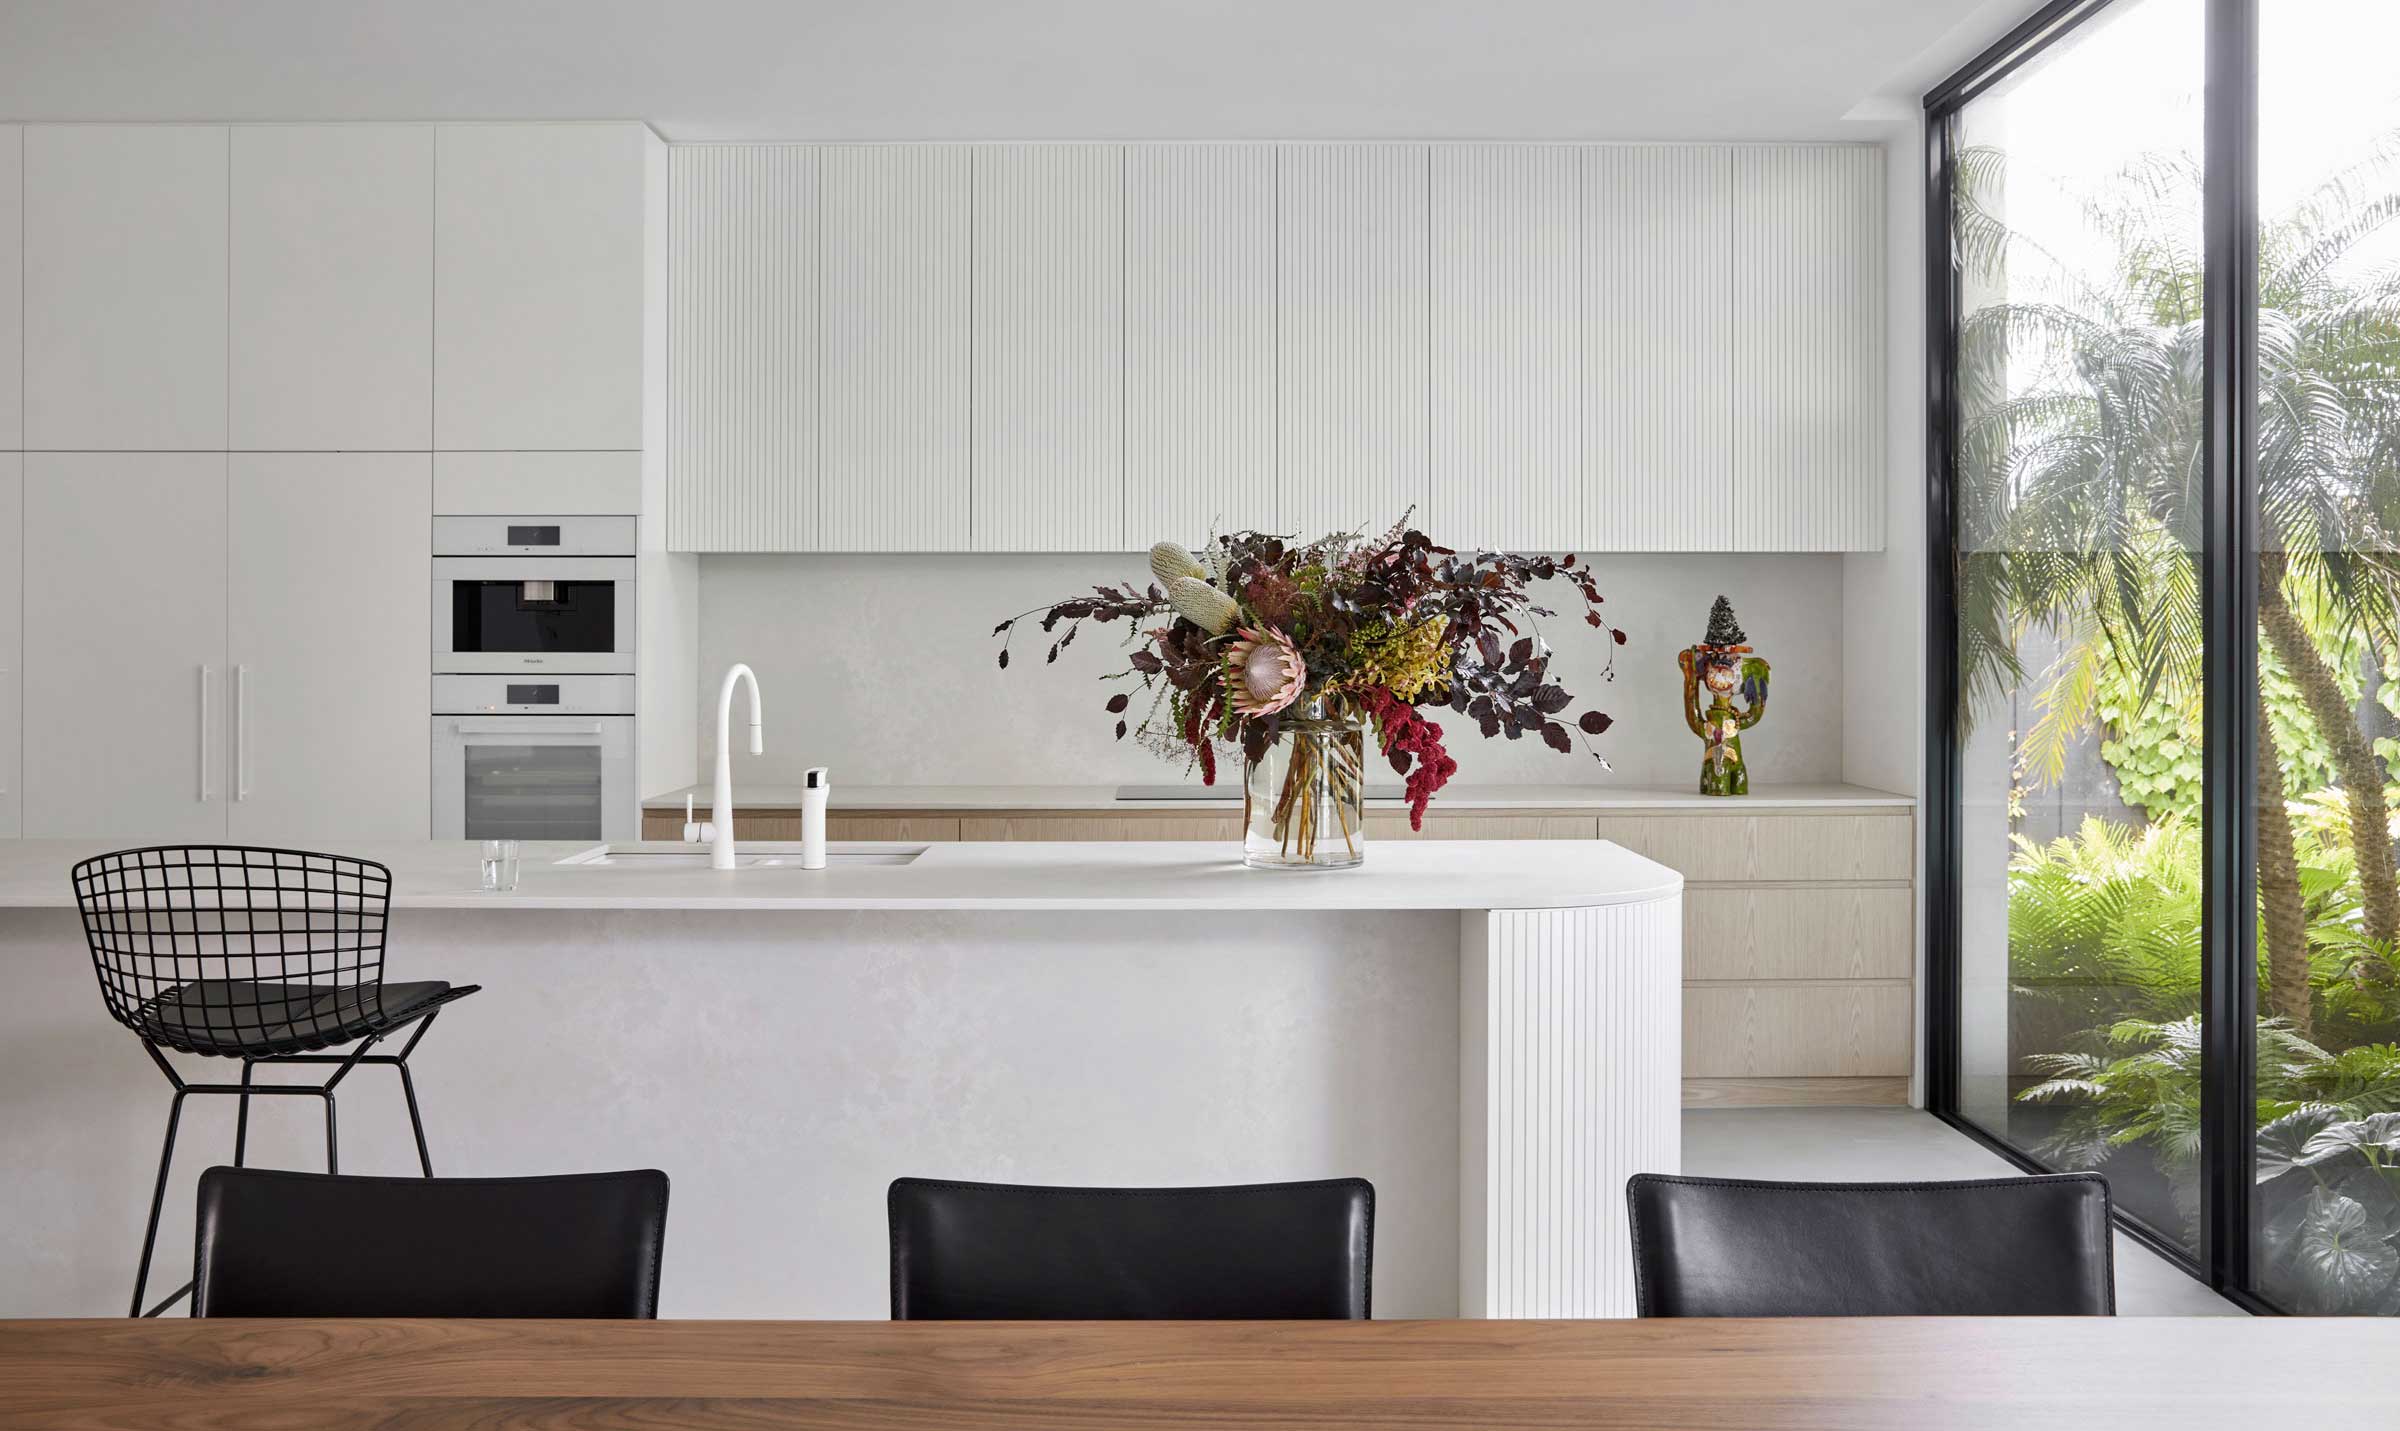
xmin=434 ymin=516 xmax=636 ymax=675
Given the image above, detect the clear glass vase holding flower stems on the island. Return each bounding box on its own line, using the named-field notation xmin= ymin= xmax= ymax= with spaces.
xmin=1241 ymin=713 xmax=1366 ymax=869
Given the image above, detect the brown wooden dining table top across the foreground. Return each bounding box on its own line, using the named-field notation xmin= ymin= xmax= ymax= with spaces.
xmin=0 ymin=1318 xmax=2400 ymax=1431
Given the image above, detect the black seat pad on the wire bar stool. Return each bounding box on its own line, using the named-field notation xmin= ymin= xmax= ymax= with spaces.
xmin=132 ymin=980 xmax=480 ymax=1059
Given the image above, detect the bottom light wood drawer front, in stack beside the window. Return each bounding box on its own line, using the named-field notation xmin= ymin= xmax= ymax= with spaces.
xmin=1682 ymin=982 xmax=1915 ymax=1078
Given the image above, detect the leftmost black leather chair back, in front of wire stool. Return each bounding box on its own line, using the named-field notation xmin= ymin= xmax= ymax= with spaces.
xmin=192 ymin=1167 xmax=667 ymax=1318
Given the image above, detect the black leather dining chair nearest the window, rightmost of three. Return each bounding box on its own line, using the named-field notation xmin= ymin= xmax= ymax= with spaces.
xmin=1625 ymin=1172 xmax=2117 ymax=1316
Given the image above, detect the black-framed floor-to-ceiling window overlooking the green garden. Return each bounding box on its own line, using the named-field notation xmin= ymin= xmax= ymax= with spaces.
xmin=1927 ymin=0 xmax=2400 ymax=1313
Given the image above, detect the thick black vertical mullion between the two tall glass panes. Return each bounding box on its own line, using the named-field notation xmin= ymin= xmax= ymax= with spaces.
xmin=2201 ymin=0 xmax=2258 ymax=1292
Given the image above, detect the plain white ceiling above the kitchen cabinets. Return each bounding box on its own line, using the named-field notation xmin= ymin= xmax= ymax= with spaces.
xmin=0 ymin=0 xmax=2035 ymax=139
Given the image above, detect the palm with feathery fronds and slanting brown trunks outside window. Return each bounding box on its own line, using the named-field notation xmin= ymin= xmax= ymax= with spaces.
xmin=1956 ymin=144 xmax=2400 ymax=1035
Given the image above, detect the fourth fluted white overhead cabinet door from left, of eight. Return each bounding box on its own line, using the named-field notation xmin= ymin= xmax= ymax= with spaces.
xmin=1126 ymin=144 xmax=1277 ymax=547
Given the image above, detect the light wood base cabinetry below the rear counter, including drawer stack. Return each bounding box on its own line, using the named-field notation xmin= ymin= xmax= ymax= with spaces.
xmin=643 ymin=807 xmax=1915 ymax=1107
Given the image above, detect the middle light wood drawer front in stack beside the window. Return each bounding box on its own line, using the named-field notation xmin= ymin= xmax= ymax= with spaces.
xmin=1682 ymin=884 xmax=1915 ymax=980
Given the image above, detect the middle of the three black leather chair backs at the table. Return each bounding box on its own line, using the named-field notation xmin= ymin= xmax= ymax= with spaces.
xmin=890 ymin=1176 xmax=1375 ymax=1321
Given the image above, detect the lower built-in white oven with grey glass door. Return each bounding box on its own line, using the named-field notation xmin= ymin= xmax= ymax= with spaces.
xmin=432 ymin=675 xmax=641 ymax=840
